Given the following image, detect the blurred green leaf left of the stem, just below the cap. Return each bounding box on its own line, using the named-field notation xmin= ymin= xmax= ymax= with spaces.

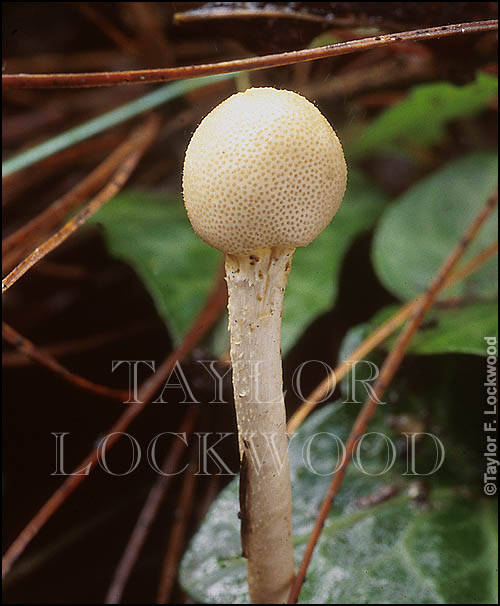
xmin=93 ymin=192 xmax=221 ymax=342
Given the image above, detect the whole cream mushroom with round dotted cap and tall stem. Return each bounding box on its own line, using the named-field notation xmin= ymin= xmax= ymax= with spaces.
xmin=183 ymin=88 xmax=347 ymax=604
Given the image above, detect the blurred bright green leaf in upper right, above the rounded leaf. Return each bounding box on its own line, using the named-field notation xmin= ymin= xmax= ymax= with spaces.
xmin=349 ymin=73 xmax=498 ymax=156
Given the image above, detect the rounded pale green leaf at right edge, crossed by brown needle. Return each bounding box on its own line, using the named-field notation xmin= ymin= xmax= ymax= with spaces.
xmin=372 ymin=153 xmax=498 ymax=299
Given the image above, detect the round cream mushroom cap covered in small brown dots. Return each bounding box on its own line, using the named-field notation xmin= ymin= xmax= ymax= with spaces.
xmin=183 ymin=88 xmax=347 ymax=254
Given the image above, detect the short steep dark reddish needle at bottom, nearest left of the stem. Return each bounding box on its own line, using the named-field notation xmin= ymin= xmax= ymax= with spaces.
xmin=156 ymin=462 xmax=198 ymax=604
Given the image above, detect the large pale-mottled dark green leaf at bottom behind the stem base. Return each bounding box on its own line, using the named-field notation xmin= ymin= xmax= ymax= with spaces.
xmin=180 ymin=403 xmax=496 ymax=604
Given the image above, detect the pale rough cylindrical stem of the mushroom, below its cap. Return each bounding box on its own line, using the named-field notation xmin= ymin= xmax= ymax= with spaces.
xmin=226 ymin=246 xmax=295 ymax=604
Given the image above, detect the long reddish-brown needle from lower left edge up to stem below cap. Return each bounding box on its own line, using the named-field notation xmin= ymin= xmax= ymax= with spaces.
xmin=2 ymin=275 xmax=227 ymax=578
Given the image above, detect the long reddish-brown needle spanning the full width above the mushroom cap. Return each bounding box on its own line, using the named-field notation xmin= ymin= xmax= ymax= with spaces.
xmin=2 ymin=19 xmax=498 ymax=89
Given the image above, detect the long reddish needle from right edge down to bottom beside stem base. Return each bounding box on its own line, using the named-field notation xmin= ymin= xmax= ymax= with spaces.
xmin=288 ymin=190 xmax=498 ymax=604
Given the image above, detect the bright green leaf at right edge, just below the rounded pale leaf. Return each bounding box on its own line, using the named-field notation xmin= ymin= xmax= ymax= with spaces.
xmin=369 ymin=303 xmax=498 ymax=356
